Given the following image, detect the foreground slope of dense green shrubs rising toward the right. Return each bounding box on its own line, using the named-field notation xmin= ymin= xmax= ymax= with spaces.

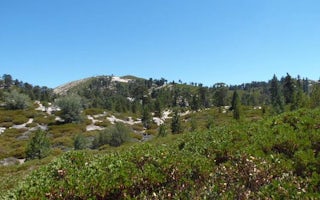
xmin=4 ymin=109 xmax=320 ymax=199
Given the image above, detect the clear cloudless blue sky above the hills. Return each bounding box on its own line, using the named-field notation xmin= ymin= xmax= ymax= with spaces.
xmin=0 ymin=0 xmax=320 ymax=87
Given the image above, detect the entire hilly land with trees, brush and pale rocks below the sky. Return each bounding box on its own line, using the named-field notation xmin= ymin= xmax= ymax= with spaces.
xmin=0 ymin=74 xmax=320 ymax=199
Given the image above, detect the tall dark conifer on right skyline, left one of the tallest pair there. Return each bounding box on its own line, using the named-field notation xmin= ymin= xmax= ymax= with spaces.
xmin=270 ymin=75 xmax=284 ymax=113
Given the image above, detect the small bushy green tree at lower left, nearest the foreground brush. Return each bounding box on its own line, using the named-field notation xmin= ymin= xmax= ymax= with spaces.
xmin=26 ymin=129 xmax=50 ymax=160
